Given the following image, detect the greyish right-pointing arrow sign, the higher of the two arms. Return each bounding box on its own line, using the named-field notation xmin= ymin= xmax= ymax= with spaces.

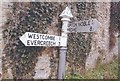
xmin=68 ymin=19 xmax=101 ymax=32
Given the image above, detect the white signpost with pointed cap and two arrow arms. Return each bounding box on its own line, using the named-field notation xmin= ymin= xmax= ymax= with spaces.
xmin=20 ymin=7 xmax=100 ymax=79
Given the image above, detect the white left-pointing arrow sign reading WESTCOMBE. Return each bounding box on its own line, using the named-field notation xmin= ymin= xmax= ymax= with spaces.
xmin=20 ymin=32 xmax=67 ymax=46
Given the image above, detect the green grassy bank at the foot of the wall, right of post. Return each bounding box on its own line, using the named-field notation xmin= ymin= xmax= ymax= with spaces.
xmin=65 ymin=61 xmax=118 ymax=79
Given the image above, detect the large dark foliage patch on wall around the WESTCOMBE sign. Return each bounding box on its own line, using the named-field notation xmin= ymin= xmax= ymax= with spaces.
xmin=3 ymin=2 xmax=57 ymax=78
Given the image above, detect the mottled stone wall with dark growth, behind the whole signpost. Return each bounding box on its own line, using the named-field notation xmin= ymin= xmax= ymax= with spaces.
xmin=0 ymin=2 xmax=117 ymax=79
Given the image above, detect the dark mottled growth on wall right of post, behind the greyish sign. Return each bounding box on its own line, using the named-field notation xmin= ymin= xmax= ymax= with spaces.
xmin=67 ymin=2 xmax=96 ymax=74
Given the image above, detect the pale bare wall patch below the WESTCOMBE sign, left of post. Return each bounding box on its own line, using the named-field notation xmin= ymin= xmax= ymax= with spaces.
xmin=33 ymin=55 xmax=50 ymax=79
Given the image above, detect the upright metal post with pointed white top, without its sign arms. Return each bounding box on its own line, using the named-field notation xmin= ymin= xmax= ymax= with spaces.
xmin=58 ymin=7 xmax=73 ymax=79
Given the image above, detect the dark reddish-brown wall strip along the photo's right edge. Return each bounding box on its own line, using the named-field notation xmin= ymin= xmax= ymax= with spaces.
xmin=109 ymin=2 xmax=120 ymax=58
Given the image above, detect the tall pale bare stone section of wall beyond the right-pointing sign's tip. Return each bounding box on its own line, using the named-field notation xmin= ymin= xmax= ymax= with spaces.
xmin=86 ymin=2 xmax=110 ymax=69
